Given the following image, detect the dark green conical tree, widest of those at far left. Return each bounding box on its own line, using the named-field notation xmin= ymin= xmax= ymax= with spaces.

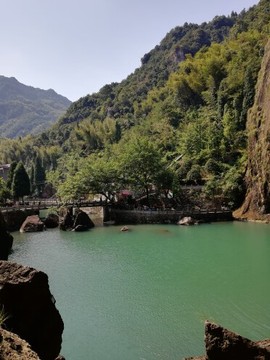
xmin=11 ymin=161 xmax=30 ymax=199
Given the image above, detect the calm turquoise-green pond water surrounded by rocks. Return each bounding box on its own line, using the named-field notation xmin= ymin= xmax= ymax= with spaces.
xmin=10 ymin=222 xmax=270 ymax=360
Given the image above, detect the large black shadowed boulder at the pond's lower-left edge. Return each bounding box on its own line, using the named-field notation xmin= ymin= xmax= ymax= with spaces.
xmin=0 ymin=261 xmax=64 ymax=360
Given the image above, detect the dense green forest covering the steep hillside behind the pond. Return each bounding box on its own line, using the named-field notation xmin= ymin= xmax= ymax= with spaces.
xmin=0 ymin=0 xmax=270 ymax=208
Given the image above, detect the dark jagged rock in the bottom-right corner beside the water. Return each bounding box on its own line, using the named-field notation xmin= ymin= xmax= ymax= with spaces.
xmin=186 ymin=321 xmax=270 ymax=360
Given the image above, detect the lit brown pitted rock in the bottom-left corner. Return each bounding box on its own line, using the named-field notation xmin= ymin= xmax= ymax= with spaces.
xmin=0 ymin=328 xmax=40 ymax=360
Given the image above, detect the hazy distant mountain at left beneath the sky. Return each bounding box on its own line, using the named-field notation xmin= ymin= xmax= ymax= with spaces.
xmin=0 ymin=76 xmax=71 ymax=138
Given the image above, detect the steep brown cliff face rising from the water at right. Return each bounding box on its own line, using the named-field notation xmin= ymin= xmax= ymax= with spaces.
xmin=234 ymin=40 xmax=270 ymax=221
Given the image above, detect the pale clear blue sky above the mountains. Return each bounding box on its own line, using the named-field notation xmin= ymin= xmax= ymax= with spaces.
xmin=0 ymin=0 xmax=258 ymax=101
